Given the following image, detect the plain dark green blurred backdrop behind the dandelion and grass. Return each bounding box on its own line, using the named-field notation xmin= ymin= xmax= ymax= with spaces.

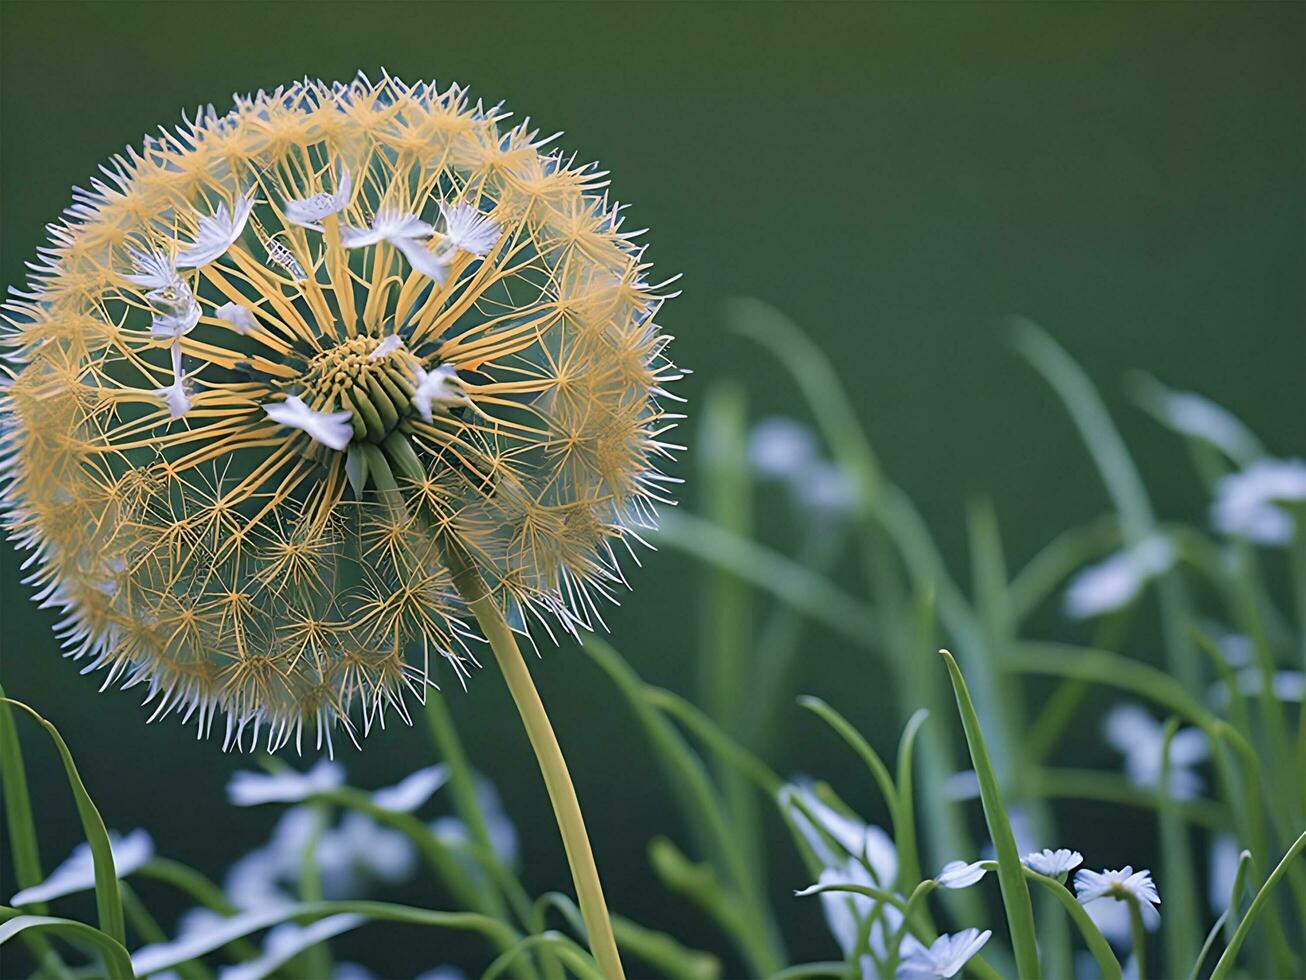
xmin=0 ymin=0 xmax=1306 ymax=975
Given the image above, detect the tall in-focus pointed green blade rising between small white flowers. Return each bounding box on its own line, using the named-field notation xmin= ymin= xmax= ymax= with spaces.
xmin=939 ymin=649 xmax=1040 ymax=980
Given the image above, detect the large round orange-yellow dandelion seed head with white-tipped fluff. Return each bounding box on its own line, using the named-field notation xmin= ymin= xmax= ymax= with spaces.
xmin=0 ymin=76 xmax=679 ymax=749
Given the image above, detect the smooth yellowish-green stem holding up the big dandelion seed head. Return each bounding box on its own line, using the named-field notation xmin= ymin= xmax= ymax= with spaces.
xmin=445 ymin=545 xmax=626 ymax=980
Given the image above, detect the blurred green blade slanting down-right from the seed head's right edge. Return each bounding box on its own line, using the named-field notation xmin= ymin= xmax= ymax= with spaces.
xmin=653 ymin=511 xmax=876 ymax=649
